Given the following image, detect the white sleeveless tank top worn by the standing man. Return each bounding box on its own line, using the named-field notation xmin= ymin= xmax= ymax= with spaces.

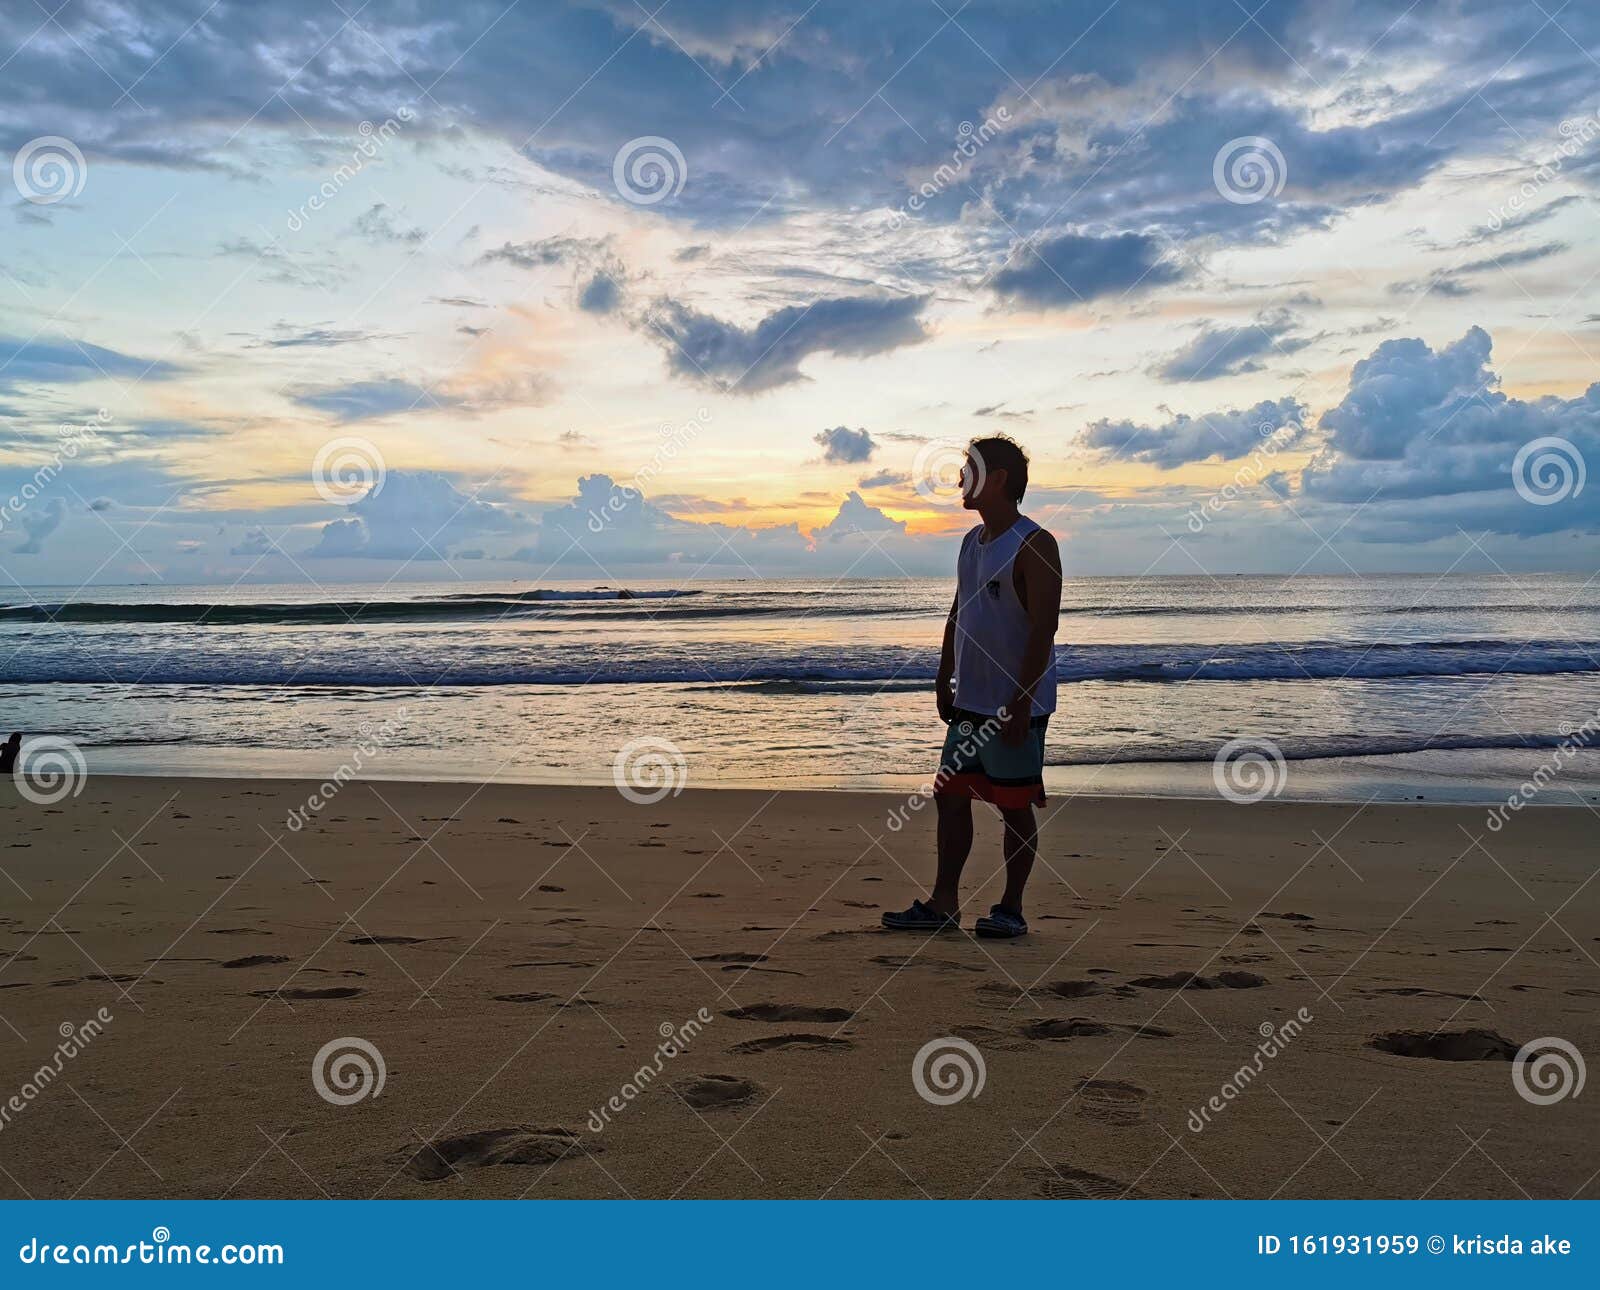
xmin=955 ymin=515 xmax=1056 ymax=717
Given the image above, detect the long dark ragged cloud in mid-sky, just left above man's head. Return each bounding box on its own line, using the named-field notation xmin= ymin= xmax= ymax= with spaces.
xmin=642 ymin=296 xmax=930 ymax=394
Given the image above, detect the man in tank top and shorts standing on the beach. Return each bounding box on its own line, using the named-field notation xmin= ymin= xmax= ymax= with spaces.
xmin=883 ymin=435 xmax=1061 ymax=938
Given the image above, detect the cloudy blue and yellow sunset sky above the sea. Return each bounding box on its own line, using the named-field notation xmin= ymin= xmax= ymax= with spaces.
xmin=0 ymin=0 xmax=1600 ymax=595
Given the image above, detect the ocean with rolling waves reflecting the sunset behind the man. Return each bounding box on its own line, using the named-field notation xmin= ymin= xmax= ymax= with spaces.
xmin=0 ymin=575 xmax=1600 ymax=803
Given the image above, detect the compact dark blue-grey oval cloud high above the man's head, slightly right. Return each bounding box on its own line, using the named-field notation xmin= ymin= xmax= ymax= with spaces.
xmin=989 ymin=234 xmax=1182 ymax=309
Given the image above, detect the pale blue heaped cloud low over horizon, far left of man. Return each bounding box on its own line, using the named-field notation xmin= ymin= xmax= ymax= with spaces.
xmin=308 ymin=471 xmax=531 ymax=560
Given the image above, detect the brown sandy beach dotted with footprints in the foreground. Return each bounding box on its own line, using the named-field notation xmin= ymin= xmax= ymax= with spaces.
xmin=0 ymin=776 xmax=1600 ymax=1199
